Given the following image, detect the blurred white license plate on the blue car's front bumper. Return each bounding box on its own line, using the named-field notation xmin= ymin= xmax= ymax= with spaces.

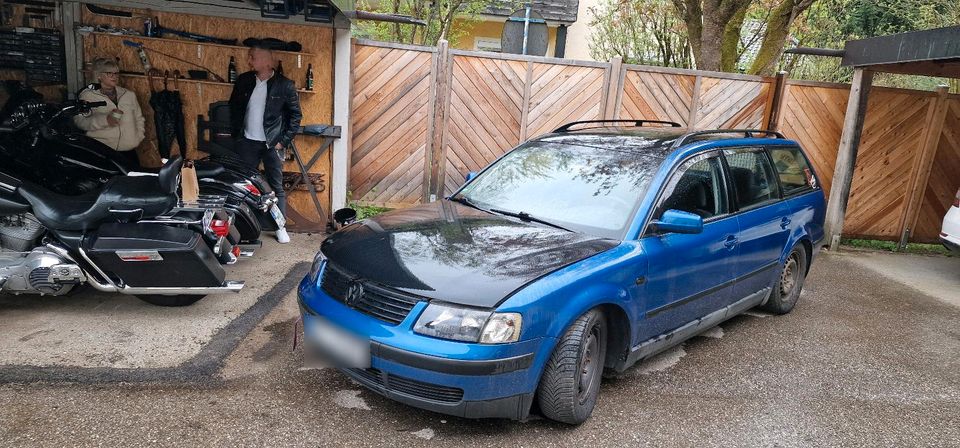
xmin=309 ymin=316 xmax=370 ymax=369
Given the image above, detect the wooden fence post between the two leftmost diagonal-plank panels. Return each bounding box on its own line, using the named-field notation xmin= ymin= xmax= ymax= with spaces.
xmin=423 ymin=40 xmax=452 ymax=202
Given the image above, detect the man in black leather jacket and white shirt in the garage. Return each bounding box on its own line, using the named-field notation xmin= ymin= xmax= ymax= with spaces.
xmin=230 ymin=46 xmax=303 ymax=243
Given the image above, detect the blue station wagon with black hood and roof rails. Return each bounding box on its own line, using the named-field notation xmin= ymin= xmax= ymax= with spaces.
xmin=298 ymin=120 xmax=825 ymax=424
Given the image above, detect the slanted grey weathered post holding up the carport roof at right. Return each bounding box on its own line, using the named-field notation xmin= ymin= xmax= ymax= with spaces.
xmin=824 ymin=68 xmax=873 ymax=251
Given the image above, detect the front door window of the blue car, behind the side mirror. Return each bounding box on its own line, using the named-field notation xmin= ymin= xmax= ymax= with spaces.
xmin=657 ymin=156 xmax=728 ymax=220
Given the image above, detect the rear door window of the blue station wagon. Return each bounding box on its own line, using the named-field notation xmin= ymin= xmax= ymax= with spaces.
xmin=723 ymin=149 xmax=780 ymax=209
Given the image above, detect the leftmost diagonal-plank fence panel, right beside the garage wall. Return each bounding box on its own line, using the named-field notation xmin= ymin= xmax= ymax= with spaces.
xmin=350 ymin=45 xmax=432 ymax=206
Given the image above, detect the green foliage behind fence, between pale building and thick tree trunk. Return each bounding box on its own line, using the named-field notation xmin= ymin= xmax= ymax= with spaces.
xmin=580 ymin=0 xmax=692 ymax=68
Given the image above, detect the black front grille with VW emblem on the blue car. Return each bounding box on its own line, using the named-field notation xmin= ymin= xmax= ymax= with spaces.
xmin=320 ymin=263 xmax=422 ymax=325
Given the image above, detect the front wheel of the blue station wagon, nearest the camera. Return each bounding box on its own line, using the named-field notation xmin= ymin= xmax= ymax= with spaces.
xmin=537 ymin=309 xmax=607 ymax=425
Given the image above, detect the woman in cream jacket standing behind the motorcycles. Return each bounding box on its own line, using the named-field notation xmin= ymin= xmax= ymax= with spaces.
xmin=73 ymin=58 xmax=144 ymax=169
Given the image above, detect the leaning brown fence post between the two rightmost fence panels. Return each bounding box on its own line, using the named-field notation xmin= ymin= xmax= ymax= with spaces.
xmin=897 ymin=85 xmax=949 ymax=249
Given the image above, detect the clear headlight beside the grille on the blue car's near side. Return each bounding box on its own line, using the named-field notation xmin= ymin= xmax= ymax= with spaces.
xmin=413 ymin=303 xmax=523 ymax=344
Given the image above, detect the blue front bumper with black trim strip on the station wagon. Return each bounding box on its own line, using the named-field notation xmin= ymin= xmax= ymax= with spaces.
xmin=298 ymin=277 xmax=552 ymax=420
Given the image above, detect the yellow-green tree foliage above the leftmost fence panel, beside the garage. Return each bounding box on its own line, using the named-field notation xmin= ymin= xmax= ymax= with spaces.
xmin=344 ymin=0 xmax=517 ymax=46
